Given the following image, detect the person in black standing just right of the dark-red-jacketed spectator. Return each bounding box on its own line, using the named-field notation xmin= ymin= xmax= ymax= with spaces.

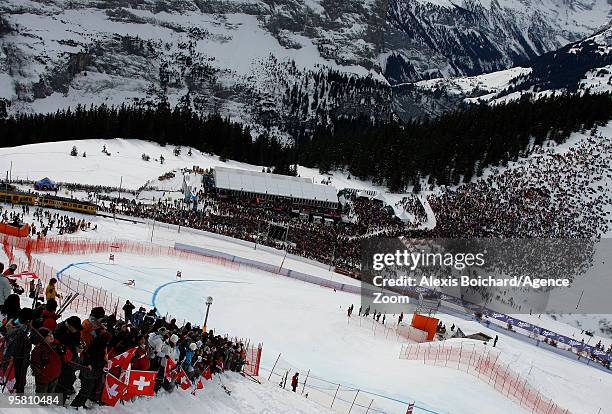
xmin=54 ymin=316 xmax=83 ymax=402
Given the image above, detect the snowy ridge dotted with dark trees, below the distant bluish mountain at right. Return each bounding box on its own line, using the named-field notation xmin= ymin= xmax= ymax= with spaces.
xmin=394 ymin=25 xmax=612 ymax=116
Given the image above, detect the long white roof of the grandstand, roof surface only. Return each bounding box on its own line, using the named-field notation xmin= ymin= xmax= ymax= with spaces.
xmin=214 ymin=167 xmax=338 ymax=203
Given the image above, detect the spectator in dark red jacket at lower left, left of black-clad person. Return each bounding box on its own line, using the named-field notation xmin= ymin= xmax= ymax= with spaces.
xmin=31 ymin=328 xmax=62 ymax=394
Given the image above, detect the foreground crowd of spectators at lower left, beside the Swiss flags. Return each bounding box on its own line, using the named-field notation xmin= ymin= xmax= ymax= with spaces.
xmin=0 ymin=260 xmax=246 ymax=408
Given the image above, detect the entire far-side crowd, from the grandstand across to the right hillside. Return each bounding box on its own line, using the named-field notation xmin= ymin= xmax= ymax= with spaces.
xmin=100 ymin=131 xmax=612 ymax=269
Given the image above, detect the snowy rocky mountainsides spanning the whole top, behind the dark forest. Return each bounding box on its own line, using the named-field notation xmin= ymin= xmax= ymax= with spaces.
xmin=0 ymin=0 xmax=611 ymax=134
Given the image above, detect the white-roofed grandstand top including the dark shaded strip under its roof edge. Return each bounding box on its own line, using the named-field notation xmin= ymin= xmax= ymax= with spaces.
xmin=213 ymin=167 xmax=338 ymax=209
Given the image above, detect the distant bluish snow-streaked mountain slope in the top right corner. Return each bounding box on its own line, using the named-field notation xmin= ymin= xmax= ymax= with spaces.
xmin=384 ymin=0 xmax=610 ymax=84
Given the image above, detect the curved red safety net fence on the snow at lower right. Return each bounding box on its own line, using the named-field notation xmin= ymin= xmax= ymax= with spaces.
xmin=400 ymin=342 xmax=571 ymax=414
